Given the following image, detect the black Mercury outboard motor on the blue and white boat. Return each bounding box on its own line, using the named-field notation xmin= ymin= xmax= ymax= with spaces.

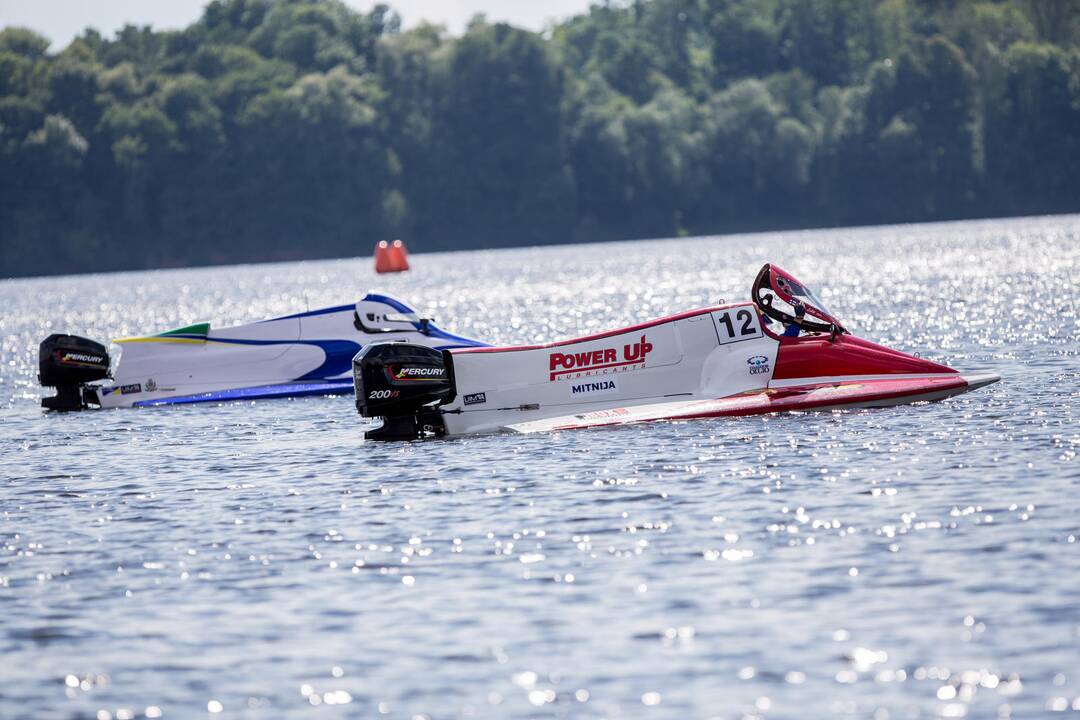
xmin=38 ymin=335 xmax=109 ymax=410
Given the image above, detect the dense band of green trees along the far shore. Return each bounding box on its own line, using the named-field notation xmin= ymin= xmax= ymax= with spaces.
xmin=0 ymin=0 xmax=1080 ymax=277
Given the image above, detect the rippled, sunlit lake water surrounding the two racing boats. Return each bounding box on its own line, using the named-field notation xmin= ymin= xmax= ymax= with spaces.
xmin=0 ymin=217 xmax=1080 ymax=719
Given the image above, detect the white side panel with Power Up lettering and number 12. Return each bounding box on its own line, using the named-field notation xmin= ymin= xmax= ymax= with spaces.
xmin=443 ymin=303 xmax=779 ymax=435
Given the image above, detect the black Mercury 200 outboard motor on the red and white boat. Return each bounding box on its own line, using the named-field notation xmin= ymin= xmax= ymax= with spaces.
xmin=352 ymin=342 xmax=455 ymax=440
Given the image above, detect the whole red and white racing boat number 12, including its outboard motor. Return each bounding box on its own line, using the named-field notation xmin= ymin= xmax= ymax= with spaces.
xmin=353 ymin=264 xmax=999 ymax=439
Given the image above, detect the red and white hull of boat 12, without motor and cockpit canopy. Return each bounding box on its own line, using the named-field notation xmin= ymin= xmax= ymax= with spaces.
xmin=427 ymin=303 xmax=998 ymax=435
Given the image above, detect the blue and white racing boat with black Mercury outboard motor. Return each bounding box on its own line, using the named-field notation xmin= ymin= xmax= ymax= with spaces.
xmin=39 ymin=293 xmax=485 ymax=410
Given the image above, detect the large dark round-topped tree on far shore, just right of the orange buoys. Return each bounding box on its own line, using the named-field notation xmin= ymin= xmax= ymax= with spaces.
xmin=416 ymin=22 xmax=573 ymax=244
